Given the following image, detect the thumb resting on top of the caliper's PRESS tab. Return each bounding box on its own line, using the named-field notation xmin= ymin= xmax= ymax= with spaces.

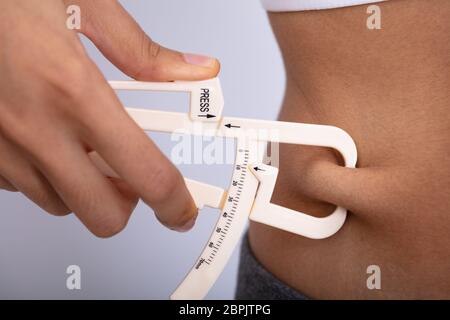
xmin=75 ymin=0 xmax=220 ymax=81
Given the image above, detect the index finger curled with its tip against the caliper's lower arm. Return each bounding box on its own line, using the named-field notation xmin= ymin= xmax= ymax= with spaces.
xmin=76 ymin=71 xmax=197 ymax=231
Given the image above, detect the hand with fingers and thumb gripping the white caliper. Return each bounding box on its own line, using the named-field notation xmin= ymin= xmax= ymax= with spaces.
xmin=0 ymin=0 xmax=219 ymax=237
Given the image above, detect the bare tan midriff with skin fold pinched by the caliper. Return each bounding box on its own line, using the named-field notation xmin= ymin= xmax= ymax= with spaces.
xmin=249 ymin=0 xmax=450 ymax=299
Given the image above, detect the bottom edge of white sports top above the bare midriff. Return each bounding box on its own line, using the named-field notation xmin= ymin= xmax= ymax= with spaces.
xmin=261 ymin=0 xmax=386 ymax=11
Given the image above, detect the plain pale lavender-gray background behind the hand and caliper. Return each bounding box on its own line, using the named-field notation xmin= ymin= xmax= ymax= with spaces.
xmin=0 ymin=0 xmax=284 ymax=299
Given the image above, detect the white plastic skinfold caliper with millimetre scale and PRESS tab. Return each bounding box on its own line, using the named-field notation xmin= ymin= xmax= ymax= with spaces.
xmin=110 ymin=78 xmax=357 ymax=299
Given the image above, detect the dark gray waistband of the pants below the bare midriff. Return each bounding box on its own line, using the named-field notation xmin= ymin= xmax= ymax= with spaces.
xmin=235 ymin=234 xmax=309 ymax=300
